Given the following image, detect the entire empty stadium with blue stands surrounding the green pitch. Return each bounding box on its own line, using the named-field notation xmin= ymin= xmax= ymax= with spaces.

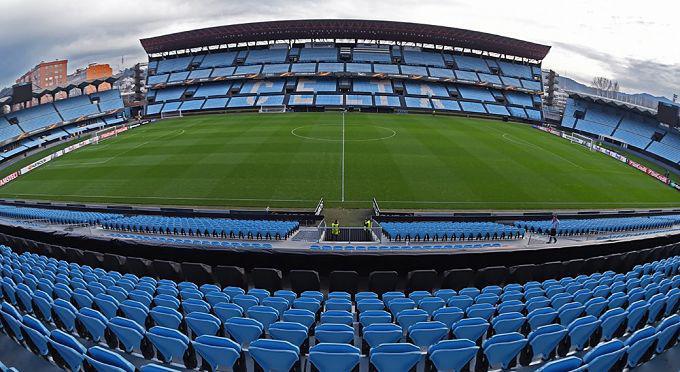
xmin=0 ymin=19 xmax=680 ymax=372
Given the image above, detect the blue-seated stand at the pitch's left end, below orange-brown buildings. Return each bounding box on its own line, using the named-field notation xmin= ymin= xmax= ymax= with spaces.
xmin=0 ymin=89 xmax=125 ymax=160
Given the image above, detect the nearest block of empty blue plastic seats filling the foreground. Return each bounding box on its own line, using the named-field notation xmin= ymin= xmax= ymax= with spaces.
xmin=0 ymin=246 xmax=680 ymax=372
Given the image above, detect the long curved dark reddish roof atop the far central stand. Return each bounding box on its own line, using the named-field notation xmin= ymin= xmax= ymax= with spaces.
xmin=141 ymin=19 xmax=550 ymax=60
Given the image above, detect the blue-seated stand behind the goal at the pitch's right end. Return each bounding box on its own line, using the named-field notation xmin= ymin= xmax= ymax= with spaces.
xmin=561 ymin=94 xmax=680 ymax=165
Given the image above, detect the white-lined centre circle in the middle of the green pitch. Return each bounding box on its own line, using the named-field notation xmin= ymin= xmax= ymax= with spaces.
xmin=290 ymin=124 xmax=397 ymax=142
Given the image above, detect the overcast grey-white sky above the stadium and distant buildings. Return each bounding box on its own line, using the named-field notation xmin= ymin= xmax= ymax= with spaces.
xmin=0 ymin=0 xmax=680 ymax=97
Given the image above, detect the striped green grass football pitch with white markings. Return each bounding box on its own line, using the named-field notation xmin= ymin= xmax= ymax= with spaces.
xmin=0 ymin=113 xmax=680 ymax=210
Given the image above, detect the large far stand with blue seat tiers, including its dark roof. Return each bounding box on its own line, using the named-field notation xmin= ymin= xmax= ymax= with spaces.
xmin=141 ymin=20 xmax=550 ymax=122
